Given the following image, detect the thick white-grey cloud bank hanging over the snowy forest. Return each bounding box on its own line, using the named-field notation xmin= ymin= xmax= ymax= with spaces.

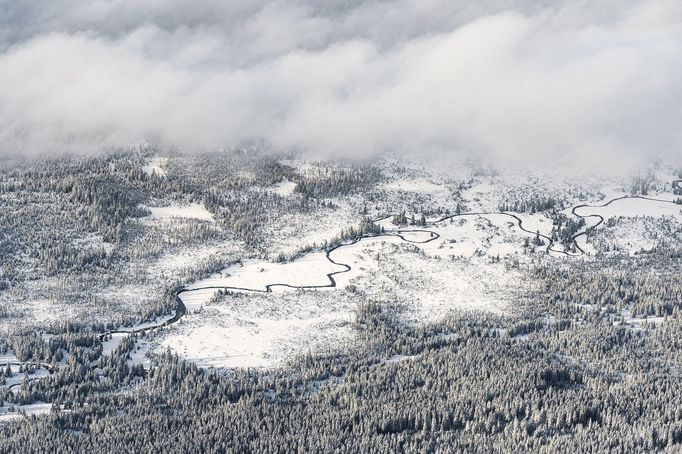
xmin=0 ymin=0 xmax=682 ymax=165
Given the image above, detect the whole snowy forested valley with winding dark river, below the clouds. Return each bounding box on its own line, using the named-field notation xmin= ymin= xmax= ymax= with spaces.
xmin=0 ymin=147 xmax=682 ymax=452
